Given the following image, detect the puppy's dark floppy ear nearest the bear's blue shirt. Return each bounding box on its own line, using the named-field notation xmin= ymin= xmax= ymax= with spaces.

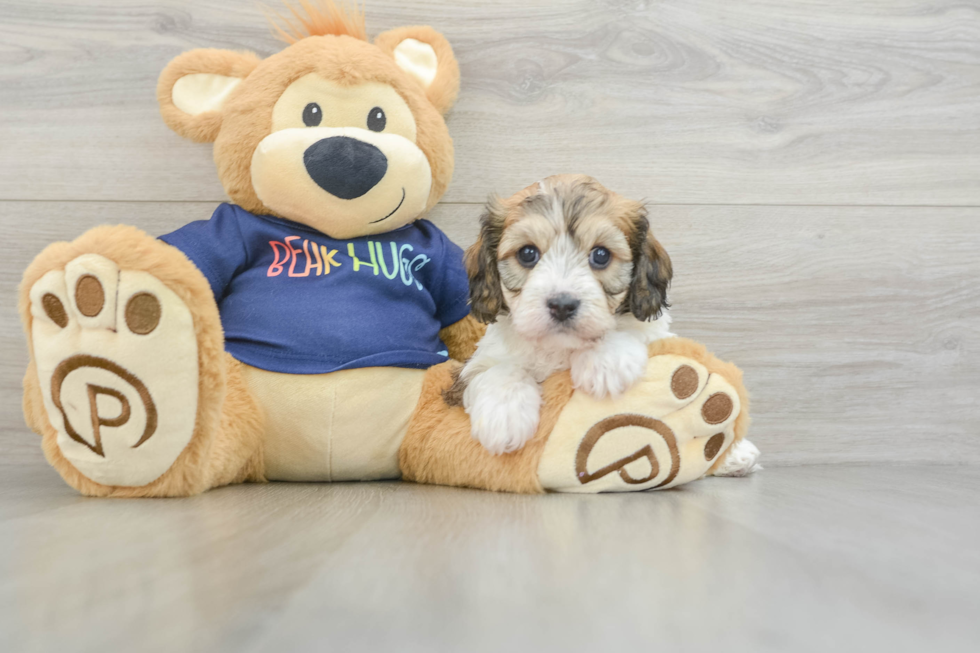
xmin=465 ymin=197 xmax=507 ymax=324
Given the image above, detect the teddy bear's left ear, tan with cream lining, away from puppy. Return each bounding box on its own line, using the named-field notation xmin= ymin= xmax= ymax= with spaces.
xmin=157 ymin=49 xmax=260 ymax=143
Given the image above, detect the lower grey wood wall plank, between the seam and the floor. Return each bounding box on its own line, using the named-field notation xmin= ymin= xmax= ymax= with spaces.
xmin=0 ymin=202 xmax=980 ymax=464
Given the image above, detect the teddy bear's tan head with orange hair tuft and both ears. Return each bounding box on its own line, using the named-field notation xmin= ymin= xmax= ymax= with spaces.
xmin=157 ymin=0 xmax=459 ymax=238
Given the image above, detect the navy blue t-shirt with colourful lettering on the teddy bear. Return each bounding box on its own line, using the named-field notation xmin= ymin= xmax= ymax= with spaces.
xmin=161 ymin=204 xmax=469 ymax=374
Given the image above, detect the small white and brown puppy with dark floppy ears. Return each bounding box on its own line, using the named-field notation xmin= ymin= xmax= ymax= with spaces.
xmin=447 ymin=175 xmax=673 ymax=454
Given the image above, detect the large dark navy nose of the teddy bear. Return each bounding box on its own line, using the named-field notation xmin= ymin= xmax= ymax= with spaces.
xmin=303 ymin=136 xmax=388 ymax=200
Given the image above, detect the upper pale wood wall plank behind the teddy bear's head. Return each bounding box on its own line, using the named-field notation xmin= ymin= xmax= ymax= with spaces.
xmin=0 ymin=0 xmax=980 ymax=205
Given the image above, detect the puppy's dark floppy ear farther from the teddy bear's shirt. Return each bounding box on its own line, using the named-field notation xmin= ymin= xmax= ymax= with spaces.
xmin=619 ymin=203 xmax=674 ymax=321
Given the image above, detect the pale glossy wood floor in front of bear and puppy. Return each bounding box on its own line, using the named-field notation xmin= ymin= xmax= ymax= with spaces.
xmin=0 ymin=465 xmax=980 ymax=653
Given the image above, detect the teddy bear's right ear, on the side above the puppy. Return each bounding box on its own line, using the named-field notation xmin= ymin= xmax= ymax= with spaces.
xmin=374 ymin=26 xmax=459 ymax=115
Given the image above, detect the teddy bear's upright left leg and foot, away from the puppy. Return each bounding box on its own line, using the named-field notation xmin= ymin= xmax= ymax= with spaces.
xmin=20 ymin=226 xmax=262 ymax=496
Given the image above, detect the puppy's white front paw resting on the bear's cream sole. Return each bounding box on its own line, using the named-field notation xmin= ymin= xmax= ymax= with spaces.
xmin=571 ymin=333 xmax=647 ymax=399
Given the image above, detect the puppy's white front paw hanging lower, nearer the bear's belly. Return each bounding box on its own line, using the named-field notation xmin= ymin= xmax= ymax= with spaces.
xmin=463 ymin=366 xmax=541 ymax=455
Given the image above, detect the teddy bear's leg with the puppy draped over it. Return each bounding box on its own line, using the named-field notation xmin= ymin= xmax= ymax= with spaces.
xmin=400 ymin=338 xmax=748 ymax=493
